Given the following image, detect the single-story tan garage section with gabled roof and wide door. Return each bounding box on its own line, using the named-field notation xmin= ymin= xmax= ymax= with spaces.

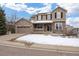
xmin=15 ymin=18 xmax=33 ymax=34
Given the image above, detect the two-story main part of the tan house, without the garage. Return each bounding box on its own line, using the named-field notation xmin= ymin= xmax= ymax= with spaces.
xmin=31 ymin=7 xmax=67 ymax=33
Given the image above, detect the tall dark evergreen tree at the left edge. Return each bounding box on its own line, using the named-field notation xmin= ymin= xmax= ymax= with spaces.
xmin=0 ymin=7 xmax=7 ymax=35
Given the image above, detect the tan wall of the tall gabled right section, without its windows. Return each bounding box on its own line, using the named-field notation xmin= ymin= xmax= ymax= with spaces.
xmin=52 ymin=8 xmax=66 ymax=33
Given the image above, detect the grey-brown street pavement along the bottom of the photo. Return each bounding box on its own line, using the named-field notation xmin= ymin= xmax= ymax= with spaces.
xmin=0 ymin=45 xmax=79 ymax=56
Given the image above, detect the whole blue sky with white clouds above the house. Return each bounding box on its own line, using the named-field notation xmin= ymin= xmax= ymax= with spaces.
xmin=0 ymin=3 xmax=79 ymax=27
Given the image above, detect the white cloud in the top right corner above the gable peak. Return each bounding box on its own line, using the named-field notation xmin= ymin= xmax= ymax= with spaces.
xmin=57 ymin=3 xmax=79 ymax=16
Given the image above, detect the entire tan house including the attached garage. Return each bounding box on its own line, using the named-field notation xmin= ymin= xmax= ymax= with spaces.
xmin=15 ymin=7 xmax=67 ymax=34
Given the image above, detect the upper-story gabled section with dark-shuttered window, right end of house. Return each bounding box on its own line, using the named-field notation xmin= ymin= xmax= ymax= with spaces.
xmin=52 ymin=6 xmax=67 ymax=20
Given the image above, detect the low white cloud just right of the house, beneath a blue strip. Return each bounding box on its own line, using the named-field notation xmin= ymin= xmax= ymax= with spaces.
xmin=67 ymin=17 xmax=79 ymax=28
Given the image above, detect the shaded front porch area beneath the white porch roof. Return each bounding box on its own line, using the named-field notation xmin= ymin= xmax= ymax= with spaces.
xmin=33 ymin=23 xmax=53 ymax=33
